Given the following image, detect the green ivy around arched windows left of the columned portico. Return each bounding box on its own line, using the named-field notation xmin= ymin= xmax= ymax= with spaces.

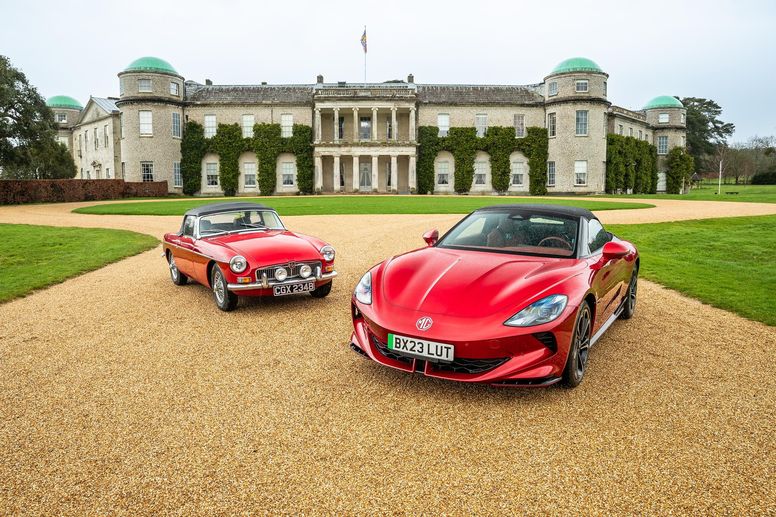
xmin=181 ymin=122 xmax=315 ymax=196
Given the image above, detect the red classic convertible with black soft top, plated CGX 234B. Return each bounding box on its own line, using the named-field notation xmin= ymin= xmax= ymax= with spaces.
xmin=162 ymin=202 xmax=337 ymax=311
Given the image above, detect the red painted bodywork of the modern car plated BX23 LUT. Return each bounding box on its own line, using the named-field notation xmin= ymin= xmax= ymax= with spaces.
xmin=351 ymin=224 xmax=638 ymax=385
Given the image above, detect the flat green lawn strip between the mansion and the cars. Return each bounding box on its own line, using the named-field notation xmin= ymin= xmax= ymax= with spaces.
xmin=73 ymin=196 xmax=653 ymax=215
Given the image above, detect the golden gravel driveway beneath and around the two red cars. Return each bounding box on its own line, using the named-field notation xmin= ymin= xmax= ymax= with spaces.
xmin=0 ymin=200 xmax=776 ymax=514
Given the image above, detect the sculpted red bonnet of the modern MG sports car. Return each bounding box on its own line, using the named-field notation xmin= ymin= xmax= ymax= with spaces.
xmin=379 ymin=247 xmax=580 ymax=318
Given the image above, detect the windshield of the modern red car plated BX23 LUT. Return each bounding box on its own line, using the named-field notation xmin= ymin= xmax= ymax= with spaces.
xmin=437 ymin=210 xmax=579 ymax=257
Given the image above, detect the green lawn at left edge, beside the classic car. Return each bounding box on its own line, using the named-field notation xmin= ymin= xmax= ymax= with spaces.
xmin=0 ymin=224 xmax=159 ymax=302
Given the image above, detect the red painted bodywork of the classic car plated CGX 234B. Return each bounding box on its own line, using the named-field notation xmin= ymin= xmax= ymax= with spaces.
xmin=162 ymin=230 xmax=334 ymax=296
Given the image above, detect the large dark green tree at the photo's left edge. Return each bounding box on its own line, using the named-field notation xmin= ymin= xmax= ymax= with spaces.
xmin=0 ymin=56 xmax=76 ymax=178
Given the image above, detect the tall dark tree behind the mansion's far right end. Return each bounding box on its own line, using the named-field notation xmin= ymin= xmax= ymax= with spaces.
xmin=680 ymin=97 xmax=735 ymax=168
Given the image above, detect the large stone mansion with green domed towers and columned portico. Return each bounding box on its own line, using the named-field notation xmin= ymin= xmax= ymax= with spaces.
xmin=47 ymin=57 xmax=686 ymax=195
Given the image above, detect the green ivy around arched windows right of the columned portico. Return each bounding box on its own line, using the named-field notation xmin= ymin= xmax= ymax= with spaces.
xmin=417 ymin=126 xmax=549 ymax=195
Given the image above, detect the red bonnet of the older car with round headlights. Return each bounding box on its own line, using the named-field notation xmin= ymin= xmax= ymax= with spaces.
xmin=208 ymin=230 xmax=321 ymax=268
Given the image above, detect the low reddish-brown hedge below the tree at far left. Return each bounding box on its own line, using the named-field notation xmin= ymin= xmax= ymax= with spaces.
xmin=0 ymin=179 xmax=167 ymax=205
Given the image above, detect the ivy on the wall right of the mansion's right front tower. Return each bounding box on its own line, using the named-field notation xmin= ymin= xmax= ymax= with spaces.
xmin=606 ymin=133 xmax=657 ymax=194
